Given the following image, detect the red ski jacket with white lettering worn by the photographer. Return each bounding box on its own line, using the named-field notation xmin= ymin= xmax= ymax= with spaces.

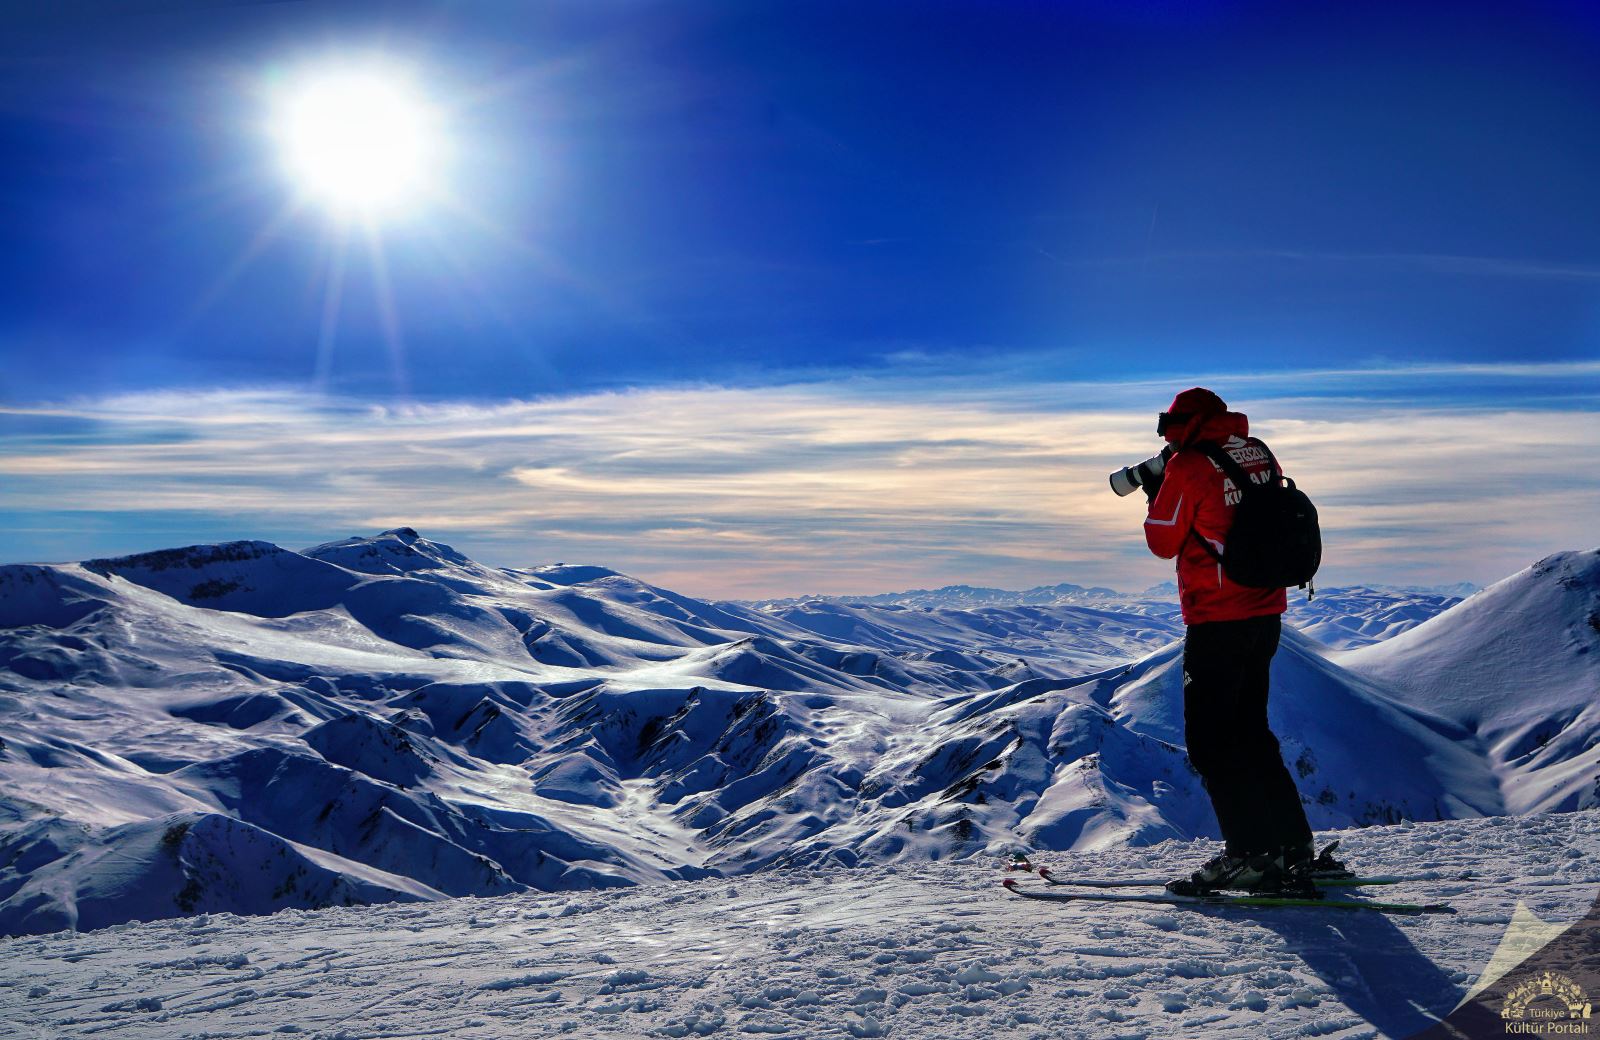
xmin=1144 ymin=411 xmax=1288 ymax=624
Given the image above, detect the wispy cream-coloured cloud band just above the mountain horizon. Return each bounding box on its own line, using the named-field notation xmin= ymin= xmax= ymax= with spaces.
xmin=0 ymin=362 xmax=1600 ymax=595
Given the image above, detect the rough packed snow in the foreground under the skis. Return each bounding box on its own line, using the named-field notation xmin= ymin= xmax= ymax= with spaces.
xmin=0 ymin=811 xmax=1600 ymax=1040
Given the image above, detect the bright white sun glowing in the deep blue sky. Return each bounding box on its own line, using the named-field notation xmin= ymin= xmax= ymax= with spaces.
xmin=270 ymin=66 xmax=446 ymax=221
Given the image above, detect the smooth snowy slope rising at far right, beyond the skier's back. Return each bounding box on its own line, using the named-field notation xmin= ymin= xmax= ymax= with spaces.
xmin=1338 ymin=549 xmax=1600 ymax=813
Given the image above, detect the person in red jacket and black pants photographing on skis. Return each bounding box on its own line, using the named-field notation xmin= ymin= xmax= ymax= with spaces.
xmin=1144 ymin=387 xmax=1338 ymax=894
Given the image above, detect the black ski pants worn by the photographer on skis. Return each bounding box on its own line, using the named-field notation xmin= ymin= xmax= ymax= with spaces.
xmin=1184 ymin=614 xmax=1310 ymax=856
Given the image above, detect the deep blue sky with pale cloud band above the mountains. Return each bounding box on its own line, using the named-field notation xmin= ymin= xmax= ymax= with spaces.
xmin=0 ymin=2 xmax=1600 ymax=595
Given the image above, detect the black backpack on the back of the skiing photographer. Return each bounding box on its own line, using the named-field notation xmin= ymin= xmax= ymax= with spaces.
xmin=1192 ymin=437 xmax=1322 ymax=595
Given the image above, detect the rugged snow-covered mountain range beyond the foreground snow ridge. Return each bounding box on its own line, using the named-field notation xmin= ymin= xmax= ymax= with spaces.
xmin=0 ymin=528 xmax=1600 ymax=931
